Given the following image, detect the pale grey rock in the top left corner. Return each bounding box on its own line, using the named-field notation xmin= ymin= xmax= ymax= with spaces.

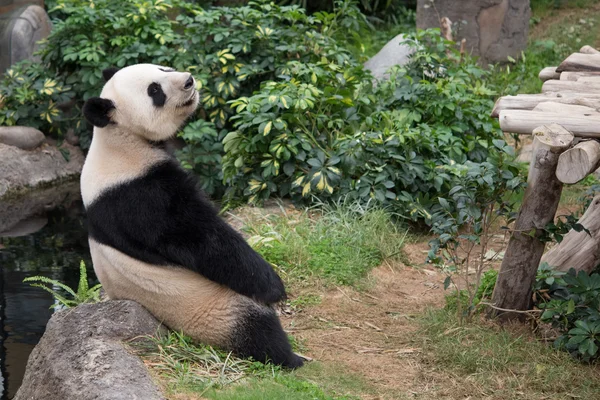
xmin=0 ymin=5 xmax=52 ymax=73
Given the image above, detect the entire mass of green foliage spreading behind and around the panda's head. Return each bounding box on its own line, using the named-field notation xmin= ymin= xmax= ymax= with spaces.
xmin=0 ymin=0 xmax=512 ymax=228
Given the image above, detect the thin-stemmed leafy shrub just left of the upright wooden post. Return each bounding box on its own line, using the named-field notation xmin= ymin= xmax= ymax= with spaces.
xmin=428 ymin=140 xmax=524 ymax=320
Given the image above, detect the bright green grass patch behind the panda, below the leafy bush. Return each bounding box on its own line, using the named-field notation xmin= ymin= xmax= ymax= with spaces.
xmin=247 ymin=203 xmax=407 ymax=285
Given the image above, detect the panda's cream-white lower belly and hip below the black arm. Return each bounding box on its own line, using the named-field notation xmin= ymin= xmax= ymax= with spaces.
xmin=89 ymin=238 xmax=239 ymax=346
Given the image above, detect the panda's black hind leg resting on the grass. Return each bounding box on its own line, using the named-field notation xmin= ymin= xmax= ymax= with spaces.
xmin=233 ymin=307 xmax=304 ymax=368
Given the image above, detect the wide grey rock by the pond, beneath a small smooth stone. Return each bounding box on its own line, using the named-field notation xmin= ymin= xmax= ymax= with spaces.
xmin=0 ymin=143 xmax=84 ymax=198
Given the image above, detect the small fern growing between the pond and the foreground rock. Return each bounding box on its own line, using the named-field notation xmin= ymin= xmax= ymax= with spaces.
xmin=23 ymin=261 xmax=102 ymax=308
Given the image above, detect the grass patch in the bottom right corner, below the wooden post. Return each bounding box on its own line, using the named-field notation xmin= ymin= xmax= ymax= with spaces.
xmin=420 ymin=310 xmax=600 ymax=399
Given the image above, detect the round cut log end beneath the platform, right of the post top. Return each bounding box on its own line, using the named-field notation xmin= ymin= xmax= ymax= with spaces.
xmin=556 ymin=140 xmax=600 ymax=183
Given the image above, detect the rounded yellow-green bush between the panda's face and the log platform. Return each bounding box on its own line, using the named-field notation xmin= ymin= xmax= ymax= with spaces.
xmin=223 ymin=30 xmax=517 ymax=222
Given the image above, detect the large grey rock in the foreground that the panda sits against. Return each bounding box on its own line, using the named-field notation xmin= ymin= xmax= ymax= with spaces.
xmin=14 ymin=301 xmax=164 ymax=400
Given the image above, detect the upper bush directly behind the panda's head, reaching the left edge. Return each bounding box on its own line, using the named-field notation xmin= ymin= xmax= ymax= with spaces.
xmin=0 ymin=0 xmax=361 ymax=194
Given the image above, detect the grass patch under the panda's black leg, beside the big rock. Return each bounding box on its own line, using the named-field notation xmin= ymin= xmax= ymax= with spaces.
xmin=131 ymin=331 xmax=358 ymax=400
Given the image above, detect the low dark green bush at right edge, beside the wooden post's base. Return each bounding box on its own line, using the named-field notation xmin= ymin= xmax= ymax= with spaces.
xmin=534 ymin=263 xmax=600 ymax=361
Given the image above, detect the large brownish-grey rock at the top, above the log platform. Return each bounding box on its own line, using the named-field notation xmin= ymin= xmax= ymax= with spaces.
xmin=417 ymin=0 xmax=531 ymax=64
